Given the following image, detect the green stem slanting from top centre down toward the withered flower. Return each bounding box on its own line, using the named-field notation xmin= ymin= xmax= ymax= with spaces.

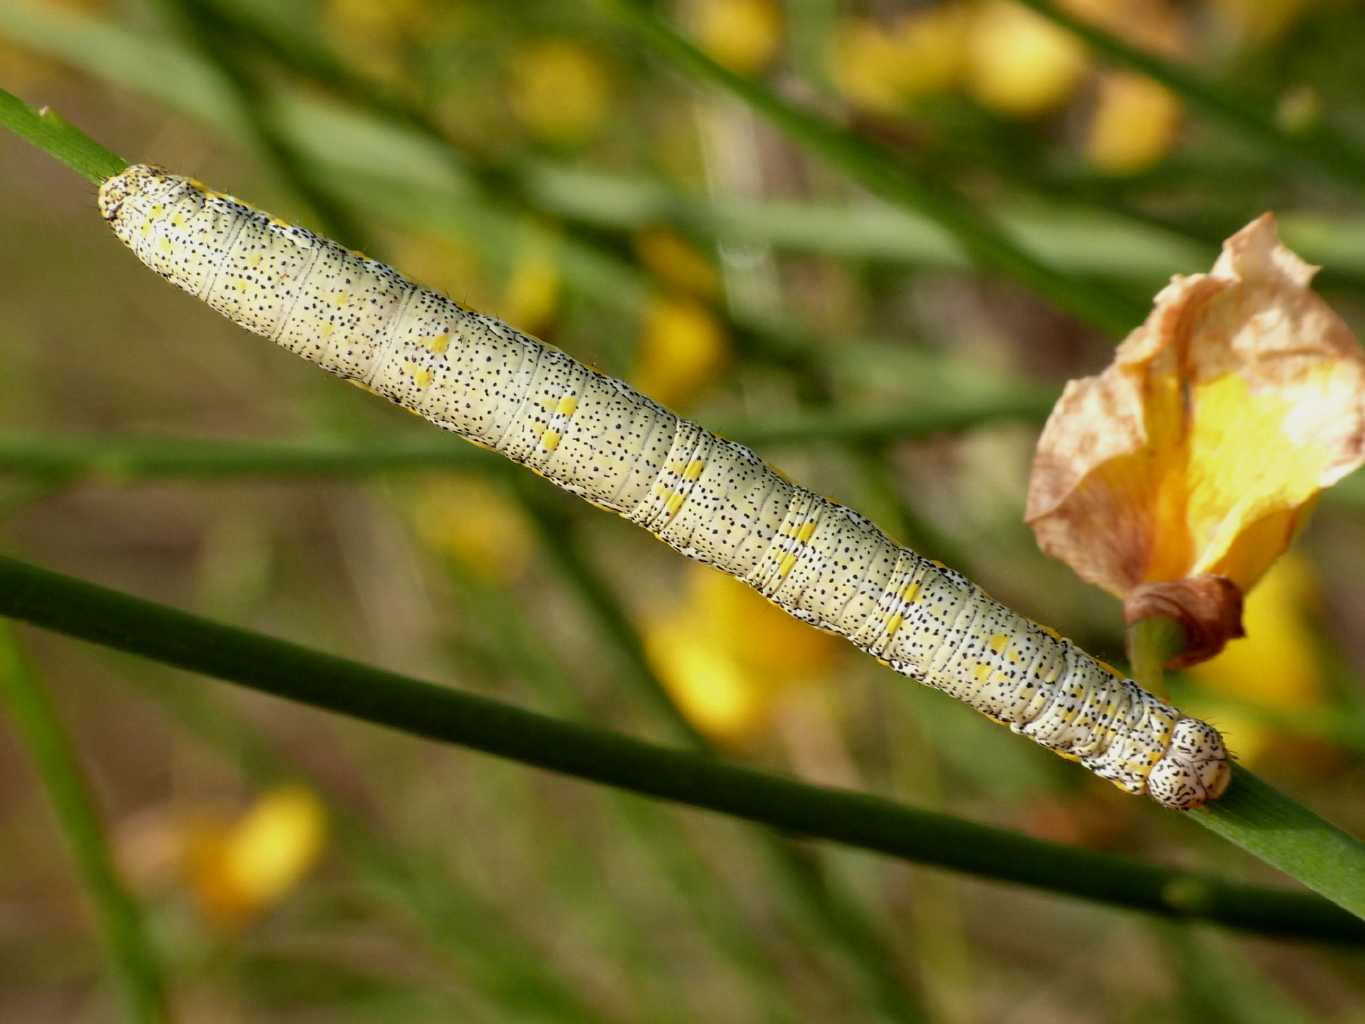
xmin=607 ymin=0 xmax=1147 ymax=336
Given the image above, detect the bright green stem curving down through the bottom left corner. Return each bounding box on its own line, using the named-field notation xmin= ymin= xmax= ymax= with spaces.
xmin=0 ymin=621 xmax=168 ymax=1024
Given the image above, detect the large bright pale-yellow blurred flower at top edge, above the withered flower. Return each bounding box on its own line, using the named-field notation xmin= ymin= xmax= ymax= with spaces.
xmin=966 ymin=0 xmax=1089 ymax=117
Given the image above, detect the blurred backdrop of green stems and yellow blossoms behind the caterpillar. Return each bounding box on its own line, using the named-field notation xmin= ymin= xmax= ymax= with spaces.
xmin=0 ymin=0 xmax=1365 ymax=1024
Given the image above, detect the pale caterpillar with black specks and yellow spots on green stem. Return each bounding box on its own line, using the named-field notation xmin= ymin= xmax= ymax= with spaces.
xmin=98 ymin=164 xmax=1231 ymax=810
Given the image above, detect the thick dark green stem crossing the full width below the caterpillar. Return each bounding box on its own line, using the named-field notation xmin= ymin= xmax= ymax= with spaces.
xmin=0 ymin=557 xmax=1365 ymax=943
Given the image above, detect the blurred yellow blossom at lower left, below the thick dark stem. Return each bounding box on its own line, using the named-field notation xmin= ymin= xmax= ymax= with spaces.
xmin=186 ymin=785 xmax=328 ymax=928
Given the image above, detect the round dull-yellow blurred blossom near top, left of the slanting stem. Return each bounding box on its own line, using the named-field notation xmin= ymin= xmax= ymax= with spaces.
xmin=509 ymin=40 xmax=612 ymax=145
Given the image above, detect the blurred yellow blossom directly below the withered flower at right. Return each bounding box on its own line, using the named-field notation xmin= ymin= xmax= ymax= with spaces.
xmin=1183 ymin=552 xmax=1327 ymax=763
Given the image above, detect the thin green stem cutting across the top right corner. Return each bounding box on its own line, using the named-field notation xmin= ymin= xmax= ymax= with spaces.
xmin=1021 ymin=0 xmax=1365 ymax=190
